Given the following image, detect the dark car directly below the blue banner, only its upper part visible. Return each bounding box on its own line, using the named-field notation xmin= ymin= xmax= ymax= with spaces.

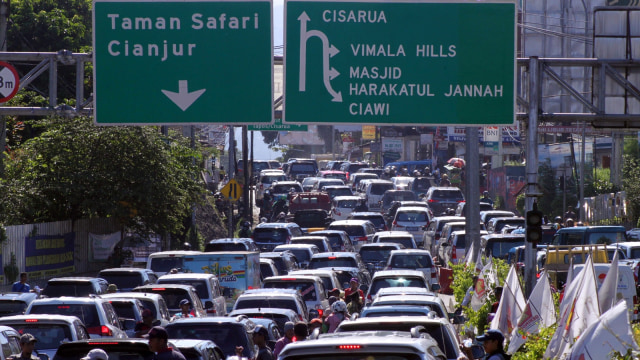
xmin=40 ymin=276 xmax=109 ymax=297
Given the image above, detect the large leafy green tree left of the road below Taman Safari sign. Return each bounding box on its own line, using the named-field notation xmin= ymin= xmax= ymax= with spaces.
xmin=0 ymin=118 xmax=202 ymax=238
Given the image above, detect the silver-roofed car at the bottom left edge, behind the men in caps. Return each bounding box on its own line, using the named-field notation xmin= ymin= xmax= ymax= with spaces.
xmin=0 ymin=314 xmax=89 ymax=359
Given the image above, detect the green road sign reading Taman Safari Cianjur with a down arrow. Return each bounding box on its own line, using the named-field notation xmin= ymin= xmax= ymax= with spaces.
xmin=93 ymin=0 xmax=273 ymax=125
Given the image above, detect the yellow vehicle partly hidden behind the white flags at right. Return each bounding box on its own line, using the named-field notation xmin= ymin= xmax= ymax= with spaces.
xmin=544 ymin=244 xmax=609 ymax=289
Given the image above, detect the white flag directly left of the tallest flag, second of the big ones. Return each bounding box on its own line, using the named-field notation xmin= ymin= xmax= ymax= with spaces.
xmin=508 ymin=271 xmax=556 ymax=354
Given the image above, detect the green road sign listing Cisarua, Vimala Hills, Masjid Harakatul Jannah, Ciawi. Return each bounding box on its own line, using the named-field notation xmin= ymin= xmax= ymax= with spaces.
xmin=283 ymin=0 xmax=516 ymax=125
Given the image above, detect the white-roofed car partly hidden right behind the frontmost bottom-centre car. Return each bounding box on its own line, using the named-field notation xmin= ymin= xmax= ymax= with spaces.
xmin=336 ymin=316 xmax=460 ymax=360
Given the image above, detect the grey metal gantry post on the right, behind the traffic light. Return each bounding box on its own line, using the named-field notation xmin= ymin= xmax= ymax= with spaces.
xmin=524 ymin=56 xmax=540 ymax=299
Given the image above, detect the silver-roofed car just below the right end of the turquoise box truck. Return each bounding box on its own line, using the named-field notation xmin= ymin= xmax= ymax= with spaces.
xmin=233 ymin=289 xmax=309 ymax=321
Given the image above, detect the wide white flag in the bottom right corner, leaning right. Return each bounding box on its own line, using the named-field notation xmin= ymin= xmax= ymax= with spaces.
xmin=569 ymin=300 xmax=639 ymax=360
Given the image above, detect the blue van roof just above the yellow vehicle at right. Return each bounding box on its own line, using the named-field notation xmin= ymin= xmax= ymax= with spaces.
xmin=552 ymin=226 xmax=627 ymax=245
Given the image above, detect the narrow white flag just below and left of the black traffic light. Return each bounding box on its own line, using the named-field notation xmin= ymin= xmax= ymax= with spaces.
xmin=491 ymin=265 xmax=526 ymax=334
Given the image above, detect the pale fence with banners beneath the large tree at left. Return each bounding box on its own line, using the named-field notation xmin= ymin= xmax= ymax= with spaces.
xmin=0 ymin=218 xmax=122 ymax=286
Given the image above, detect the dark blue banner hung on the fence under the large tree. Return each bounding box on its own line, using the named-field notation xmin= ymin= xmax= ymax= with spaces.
xmin=25 ymin=232 xmax=76 ymax=275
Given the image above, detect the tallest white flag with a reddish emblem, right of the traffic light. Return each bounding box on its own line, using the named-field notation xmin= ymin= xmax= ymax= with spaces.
xmin=544 ymin=256 xmax=600 ymax=359
